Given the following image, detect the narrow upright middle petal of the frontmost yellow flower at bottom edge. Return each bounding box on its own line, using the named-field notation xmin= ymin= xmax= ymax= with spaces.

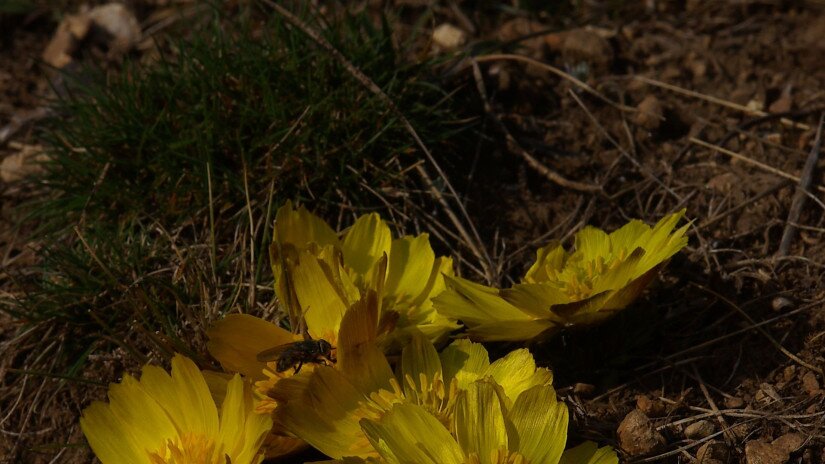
xmin=454 ymin=380 xmax=508 ymax=464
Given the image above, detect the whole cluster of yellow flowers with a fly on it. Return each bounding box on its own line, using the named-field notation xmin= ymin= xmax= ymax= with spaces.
xmin=80 ymin=203 xmax=687 ymax=464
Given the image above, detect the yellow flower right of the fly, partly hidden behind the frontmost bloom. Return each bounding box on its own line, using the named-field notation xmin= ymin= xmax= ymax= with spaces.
xmin=272 ymin=334 xmax=553 ymax=462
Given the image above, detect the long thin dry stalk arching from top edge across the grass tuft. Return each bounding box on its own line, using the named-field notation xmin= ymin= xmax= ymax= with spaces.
xmin=261 ymin=0 xmax=494 ymax=280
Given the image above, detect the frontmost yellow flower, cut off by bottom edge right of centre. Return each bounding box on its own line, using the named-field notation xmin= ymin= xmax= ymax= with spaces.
xmin=350 ymin=380 xmax=618 ymax=464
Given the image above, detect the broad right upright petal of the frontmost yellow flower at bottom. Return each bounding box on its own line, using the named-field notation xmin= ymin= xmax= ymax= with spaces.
xmin=509 ymin=385 xmax=568 ymax=463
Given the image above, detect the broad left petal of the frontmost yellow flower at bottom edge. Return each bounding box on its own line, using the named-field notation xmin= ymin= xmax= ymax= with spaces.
xmin=361 ymin=403 xmax=465 ymax=464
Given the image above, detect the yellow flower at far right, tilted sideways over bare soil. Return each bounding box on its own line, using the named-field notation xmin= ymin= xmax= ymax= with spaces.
xmin=434 ymin=210 xmax=688 ymax=341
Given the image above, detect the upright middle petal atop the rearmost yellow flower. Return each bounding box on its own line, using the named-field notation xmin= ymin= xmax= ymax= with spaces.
xmin=342 ymin=213 xmax=392 ymax=283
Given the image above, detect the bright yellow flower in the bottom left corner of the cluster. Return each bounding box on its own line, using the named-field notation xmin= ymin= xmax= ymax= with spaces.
xmin=80 ymin=355 xmax=272 ymax=464
